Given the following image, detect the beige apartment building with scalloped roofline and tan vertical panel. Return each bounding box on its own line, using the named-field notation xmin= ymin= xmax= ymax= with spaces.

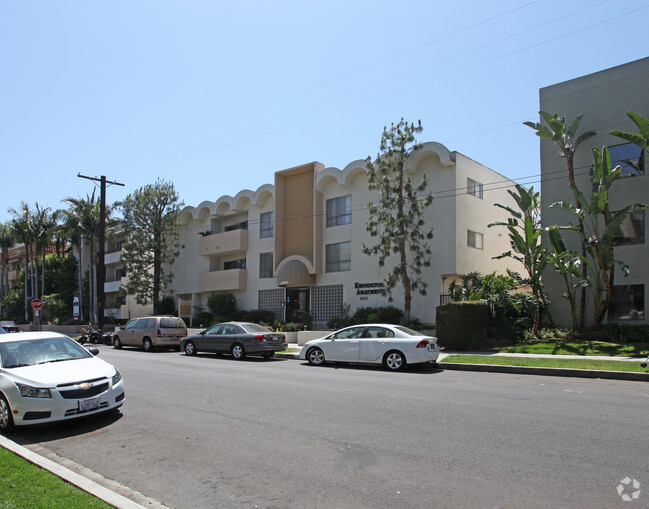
xmin=169 ymin=142 xmax=520 ymax=328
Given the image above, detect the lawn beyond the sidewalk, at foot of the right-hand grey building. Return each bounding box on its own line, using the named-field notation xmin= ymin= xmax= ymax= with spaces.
xmin=495 ymin=340 xmax=649 ymax=358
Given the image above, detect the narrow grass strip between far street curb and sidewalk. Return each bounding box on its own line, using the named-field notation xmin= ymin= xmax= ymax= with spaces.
xmin=441 ymin=355 xmax=649 ymax=373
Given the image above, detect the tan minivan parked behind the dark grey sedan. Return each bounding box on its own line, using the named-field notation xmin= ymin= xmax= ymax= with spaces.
xmin=113 ymin=316 xmax=187 ymax=352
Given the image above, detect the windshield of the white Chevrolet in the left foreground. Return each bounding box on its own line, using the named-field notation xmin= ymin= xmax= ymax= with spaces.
xmin=0 ymin=337 xmax=92 ymax=369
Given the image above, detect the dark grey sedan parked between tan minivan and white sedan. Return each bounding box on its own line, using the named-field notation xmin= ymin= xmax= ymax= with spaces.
xmin=180 ymin=322 xmax=287 ymax=359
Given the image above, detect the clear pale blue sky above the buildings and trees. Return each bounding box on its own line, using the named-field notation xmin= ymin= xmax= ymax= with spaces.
xmin=0 ymin=0 xmax=649 ymax=222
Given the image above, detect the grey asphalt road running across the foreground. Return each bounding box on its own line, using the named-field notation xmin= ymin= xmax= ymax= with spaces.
xmin=12 ymin=346 xmax=649 ymax=508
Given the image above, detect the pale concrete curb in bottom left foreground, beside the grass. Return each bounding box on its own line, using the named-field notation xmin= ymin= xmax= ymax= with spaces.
xmin=0 ymin=435 xmax=161 ymax=509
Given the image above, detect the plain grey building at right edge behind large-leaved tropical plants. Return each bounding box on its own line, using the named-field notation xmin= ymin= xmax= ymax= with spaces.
xmin=539 ymin=58 xmax=649 ymax=327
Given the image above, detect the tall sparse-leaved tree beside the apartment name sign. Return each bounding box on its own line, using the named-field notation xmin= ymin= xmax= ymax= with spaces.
xmin=363 ymin=119 xmax=433 ymax=324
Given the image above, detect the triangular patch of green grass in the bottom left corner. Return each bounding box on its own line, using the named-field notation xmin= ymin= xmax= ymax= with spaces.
xmin=0 ymin=447 xmax=112 ymax=509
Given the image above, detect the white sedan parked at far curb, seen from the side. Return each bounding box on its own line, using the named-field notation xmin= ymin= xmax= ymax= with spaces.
xmin=299 ymin=323 xmax=439 ymax=371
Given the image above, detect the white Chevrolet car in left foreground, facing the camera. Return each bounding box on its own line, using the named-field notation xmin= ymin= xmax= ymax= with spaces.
xmin=0 ymin=332 xmax=124 ymax=432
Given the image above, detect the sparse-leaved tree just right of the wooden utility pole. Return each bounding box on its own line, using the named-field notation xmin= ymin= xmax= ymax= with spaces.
xmin=122 ymin=179 xmax=182 ymax=314
